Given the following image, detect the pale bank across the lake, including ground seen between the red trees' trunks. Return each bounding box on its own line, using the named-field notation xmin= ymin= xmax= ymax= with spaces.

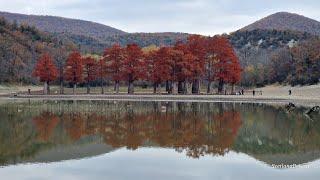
xmin=0 ymin=85 xmax=320 ymax=106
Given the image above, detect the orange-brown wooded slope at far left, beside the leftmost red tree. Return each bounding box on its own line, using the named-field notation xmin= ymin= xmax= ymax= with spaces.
xmin=0 ymin=18 xmax=76 ymax=82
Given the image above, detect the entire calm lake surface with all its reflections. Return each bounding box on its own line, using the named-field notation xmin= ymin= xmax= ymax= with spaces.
xmin=0 ymin=100 xmax=320 ymax=180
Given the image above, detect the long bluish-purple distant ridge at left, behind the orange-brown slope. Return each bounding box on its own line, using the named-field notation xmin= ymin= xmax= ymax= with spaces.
xmin=0 ymin=12 xmax=189 ymax=54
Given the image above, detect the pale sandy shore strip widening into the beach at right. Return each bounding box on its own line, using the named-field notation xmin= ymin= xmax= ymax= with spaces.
xmin=2 ymin=85 xmax=320 ymax=106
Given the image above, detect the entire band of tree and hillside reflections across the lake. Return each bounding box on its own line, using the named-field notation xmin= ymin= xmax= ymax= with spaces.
xmin=0 ymin=101 xmax=320 ymax=164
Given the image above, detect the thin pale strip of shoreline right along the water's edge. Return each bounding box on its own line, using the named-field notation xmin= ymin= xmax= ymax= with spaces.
xmin=0 ymin=94 xmax=320 ymax=106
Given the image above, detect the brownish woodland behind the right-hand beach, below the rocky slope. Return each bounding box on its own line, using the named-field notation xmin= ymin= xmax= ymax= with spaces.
xmin=240 ymin=37 xmax=320 ymax=87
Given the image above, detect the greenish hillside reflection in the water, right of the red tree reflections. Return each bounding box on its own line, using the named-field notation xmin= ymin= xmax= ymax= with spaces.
xmin=233 ymin=104 xmax=320 ymax=154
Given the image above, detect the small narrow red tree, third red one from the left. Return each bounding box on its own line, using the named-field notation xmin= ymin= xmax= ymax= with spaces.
xmin=83 ymin=57 xmax=98 ymax=94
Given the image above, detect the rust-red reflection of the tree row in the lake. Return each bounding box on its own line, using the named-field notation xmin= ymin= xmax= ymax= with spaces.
xmin=33 ymin=104 xmax=241 ymax=157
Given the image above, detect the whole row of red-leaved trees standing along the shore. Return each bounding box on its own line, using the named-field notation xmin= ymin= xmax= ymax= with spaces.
xmin=33 ymin=35 xmax=242 ymax=94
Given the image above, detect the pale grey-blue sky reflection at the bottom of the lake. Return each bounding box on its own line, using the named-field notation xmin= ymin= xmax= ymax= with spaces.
xmin=0 ymin=148 xmax=320 ymax=180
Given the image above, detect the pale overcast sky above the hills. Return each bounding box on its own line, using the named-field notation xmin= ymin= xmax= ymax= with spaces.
xmin=0 ymin=0 xmax=320 ymax=35
